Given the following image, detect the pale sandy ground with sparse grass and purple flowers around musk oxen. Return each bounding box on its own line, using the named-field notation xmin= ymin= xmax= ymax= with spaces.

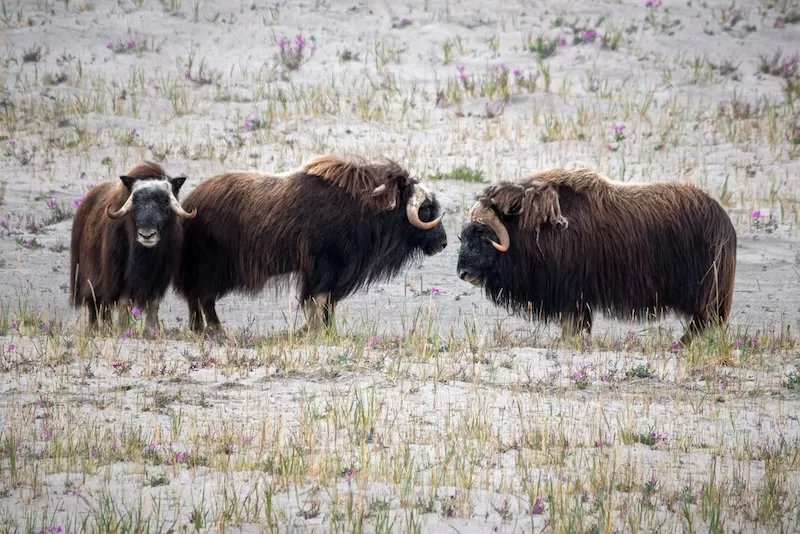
xmin=0 ymin=0 xmax=800 ymax=533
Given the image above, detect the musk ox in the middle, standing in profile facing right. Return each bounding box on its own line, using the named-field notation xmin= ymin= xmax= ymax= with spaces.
xmin=174 ymin=154 xmax=447 ymax=332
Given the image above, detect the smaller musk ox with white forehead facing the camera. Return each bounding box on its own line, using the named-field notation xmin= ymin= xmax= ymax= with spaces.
xmin=70 ymin=162 xmax=197 ymax=328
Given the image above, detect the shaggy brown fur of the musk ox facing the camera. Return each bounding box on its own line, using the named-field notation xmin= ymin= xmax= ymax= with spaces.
xmin=70 ymin=162 xmax=192 ymax=327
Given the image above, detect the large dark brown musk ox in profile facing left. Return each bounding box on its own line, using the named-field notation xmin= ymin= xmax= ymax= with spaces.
xmin=457 ymin=168 xmax=736 ymax=344
